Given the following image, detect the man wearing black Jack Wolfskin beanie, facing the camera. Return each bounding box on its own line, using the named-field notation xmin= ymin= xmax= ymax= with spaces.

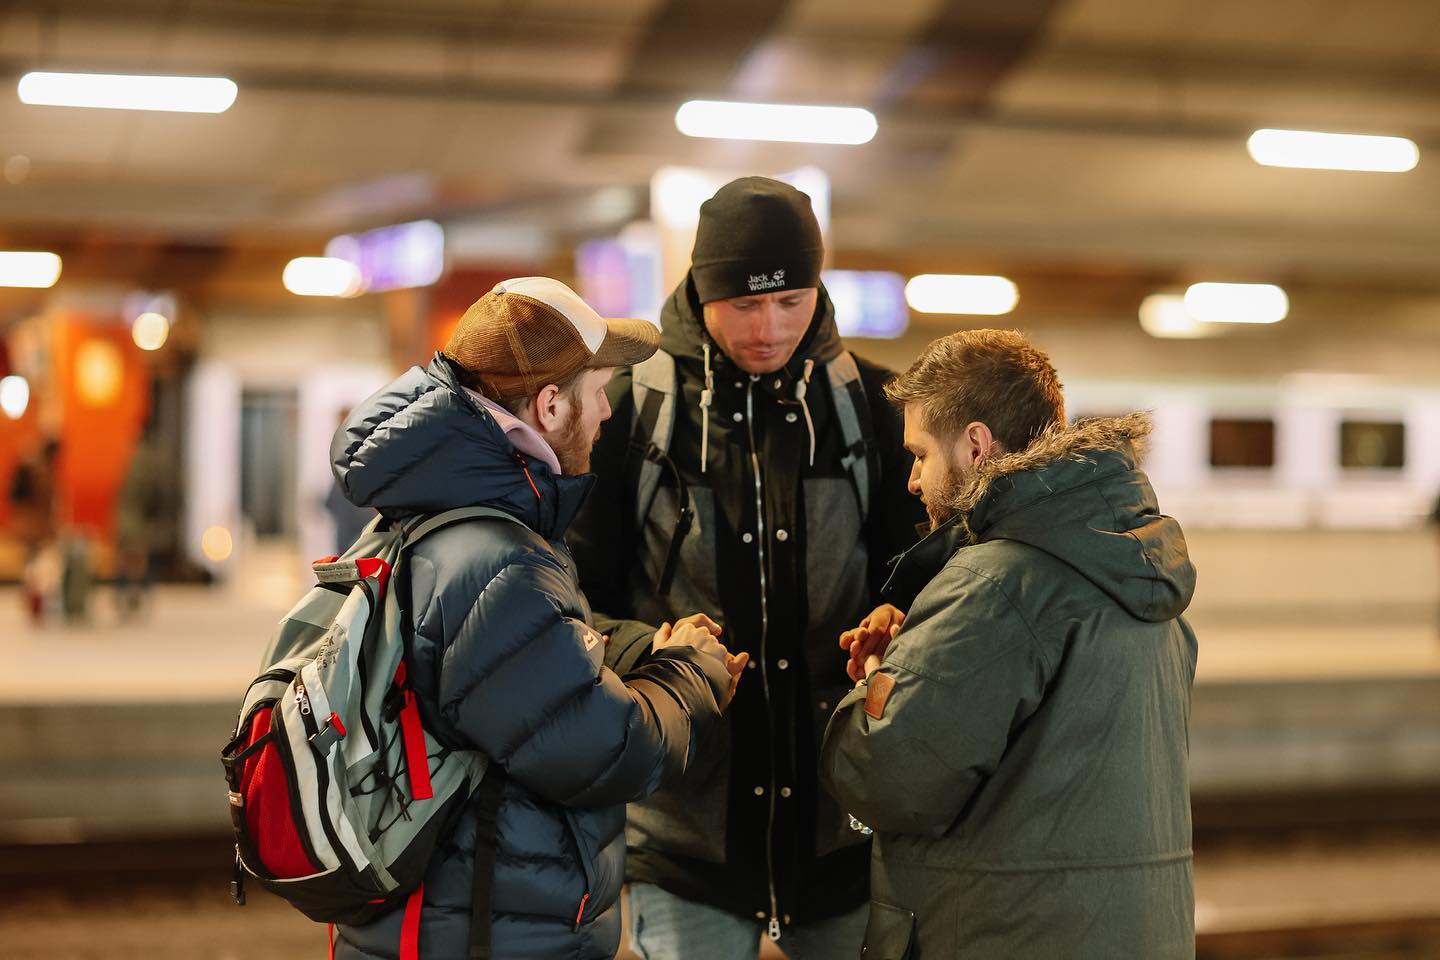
xmin=570 ymin=177 xmax=924 ymax=960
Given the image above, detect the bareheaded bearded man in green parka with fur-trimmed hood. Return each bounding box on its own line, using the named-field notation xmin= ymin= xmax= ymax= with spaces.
xmin=821 ymin=330 xmax=1195 ymax=960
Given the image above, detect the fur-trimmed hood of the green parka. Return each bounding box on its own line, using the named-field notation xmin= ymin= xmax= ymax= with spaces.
xmin=952 ymin=413 xmax=1195 ymax=623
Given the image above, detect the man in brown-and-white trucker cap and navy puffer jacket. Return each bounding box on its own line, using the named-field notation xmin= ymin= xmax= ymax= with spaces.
xmin=331 ymin=276 xmax=746 ymax=960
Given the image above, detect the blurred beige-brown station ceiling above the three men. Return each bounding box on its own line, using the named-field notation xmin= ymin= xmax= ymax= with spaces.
xmin=0 ymin=0 xmax=1440 ymax=292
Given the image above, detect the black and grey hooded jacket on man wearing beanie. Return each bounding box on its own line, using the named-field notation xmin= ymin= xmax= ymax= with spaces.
xmin=572 ymin=279 xmax=923 ymax=943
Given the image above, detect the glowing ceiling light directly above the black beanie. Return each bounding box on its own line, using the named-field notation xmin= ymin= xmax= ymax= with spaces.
xmin=675 ymin=99 xmax=880 ymax=144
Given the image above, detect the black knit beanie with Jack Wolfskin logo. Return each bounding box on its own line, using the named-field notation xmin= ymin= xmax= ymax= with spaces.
xmin=690 ymin=177 xmax=825 ymax=304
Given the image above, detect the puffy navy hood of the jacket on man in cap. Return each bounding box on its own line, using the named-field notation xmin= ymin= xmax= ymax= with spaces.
xmin=330 ymin=353 xmax=595 ymax=540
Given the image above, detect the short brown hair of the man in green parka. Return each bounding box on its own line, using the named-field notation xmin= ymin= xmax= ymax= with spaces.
xmin=886 ymin=330 xmax=1066 ymax=453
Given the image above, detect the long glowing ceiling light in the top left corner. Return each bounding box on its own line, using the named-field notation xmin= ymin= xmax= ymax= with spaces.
xmin=19 ymin=72 xmax=239 ymax=114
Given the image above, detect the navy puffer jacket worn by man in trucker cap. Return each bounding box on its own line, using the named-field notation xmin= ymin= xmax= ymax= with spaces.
xmin=331 ymin=354 xmax=730 ymax=960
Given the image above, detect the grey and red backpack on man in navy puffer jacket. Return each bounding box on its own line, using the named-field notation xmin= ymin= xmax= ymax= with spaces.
xmin=220 ymin=507 xmax=520 ymax=960
